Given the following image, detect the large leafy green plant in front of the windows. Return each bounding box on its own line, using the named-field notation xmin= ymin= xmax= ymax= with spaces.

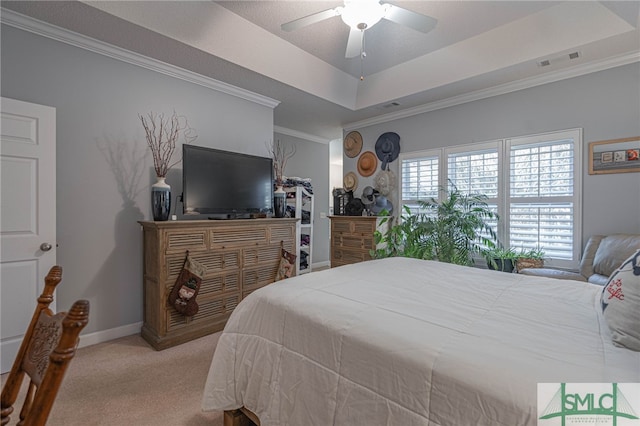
xmin=371 ymin=184 xmax=498 ymax=265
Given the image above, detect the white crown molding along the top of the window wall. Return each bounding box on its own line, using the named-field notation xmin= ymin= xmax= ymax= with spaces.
xmin=343 ymin=52 xmax=640 ymax=132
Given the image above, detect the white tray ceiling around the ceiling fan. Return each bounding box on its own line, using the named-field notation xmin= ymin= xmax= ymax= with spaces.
xmin=2 ymin=0 xmax=640 ymax=140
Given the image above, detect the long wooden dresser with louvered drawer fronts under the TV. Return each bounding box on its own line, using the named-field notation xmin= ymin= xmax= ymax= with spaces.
xmin=140 ymin=219 xmax=298 ymax=350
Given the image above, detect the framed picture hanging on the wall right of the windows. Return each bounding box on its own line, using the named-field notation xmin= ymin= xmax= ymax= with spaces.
xmin=589 ymin=136 xmax=640 ymax=175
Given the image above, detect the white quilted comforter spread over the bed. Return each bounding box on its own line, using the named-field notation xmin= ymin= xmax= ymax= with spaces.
xmin=202 ymin=258 xmax=640 ymax=426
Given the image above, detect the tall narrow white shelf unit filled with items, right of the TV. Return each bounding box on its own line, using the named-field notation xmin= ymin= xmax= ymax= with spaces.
xmin=285 ymin=186 xmax=313 ymax=275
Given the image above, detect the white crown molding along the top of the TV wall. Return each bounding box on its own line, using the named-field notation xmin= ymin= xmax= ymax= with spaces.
xmin=0 ymin=8 xmax=280 ymax=109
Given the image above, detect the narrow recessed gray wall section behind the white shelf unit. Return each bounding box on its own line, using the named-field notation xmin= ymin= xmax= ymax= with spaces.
xmin=274 ymin=133 xmax=329 ymax=264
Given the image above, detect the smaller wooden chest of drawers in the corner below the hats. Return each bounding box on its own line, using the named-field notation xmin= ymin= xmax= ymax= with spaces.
xmin=329 ymin=216 xmax=388 ymax=268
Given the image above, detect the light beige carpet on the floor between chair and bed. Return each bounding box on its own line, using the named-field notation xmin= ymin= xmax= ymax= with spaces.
xmin=2 ymin=333 xmax=222 ymax=426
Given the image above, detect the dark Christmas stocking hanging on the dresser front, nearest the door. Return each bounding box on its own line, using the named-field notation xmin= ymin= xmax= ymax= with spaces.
xmin=169 ymin=251 xmax=207 ymax=317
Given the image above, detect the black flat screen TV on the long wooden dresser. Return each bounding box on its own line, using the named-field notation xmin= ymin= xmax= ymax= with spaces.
xmin=182 ymin=144 xmax=273 ymax=219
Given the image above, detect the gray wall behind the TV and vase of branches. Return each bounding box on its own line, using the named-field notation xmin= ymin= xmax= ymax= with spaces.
xmin=1 ymin=25 xmax=273 ymax=333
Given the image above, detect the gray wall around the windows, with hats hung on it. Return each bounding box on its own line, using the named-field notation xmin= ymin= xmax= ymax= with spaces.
xmin=343 ymin=63 xmax=640 ymax=242
